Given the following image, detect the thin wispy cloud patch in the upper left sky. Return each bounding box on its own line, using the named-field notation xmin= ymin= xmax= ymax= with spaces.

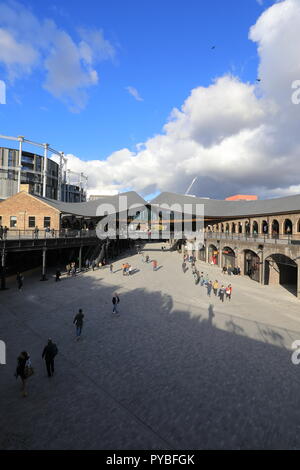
xmin=0 ymin=0 xmax=115 ymax=111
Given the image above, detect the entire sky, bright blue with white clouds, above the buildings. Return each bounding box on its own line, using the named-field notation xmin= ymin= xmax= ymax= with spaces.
xmin=0 ymin=0 xmax=300 ymax=199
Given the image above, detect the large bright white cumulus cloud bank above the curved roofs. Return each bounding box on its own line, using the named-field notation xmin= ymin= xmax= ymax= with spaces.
xmin=58 ymin=0 xmax=300 ymax=198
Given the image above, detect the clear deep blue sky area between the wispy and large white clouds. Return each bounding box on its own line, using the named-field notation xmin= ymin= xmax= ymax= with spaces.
xmin=0 ymin=0 xmax=271 ymax=160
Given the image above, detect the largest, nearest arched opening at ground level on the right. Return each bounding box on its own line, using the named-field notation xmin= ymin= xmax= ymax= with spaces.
xmin=265 ymin=254 xmax=298 ymax=295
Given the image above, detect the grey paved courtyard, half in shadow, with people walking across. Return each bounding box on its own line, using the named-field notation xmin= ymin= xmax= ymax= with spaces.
xmin=0 ymin=245 xmax=300 ymax=450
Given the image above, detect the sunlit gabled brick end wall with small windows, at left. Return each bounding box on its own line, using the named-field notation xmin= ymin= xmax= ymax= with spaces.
xmin=0 ymin=192 xmax=60 ymax=230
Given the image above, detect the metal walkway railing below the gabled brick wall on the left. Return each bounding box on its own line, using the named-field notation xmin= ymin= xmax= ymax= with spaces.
xmin=0 ymin=229 xmax=97 ymax=241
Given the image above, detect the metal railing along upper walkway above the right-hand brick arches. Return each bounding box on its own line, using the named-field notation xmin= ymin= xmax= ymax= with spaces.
xmin=204 ymin=232 xmax=300 ymax=245
